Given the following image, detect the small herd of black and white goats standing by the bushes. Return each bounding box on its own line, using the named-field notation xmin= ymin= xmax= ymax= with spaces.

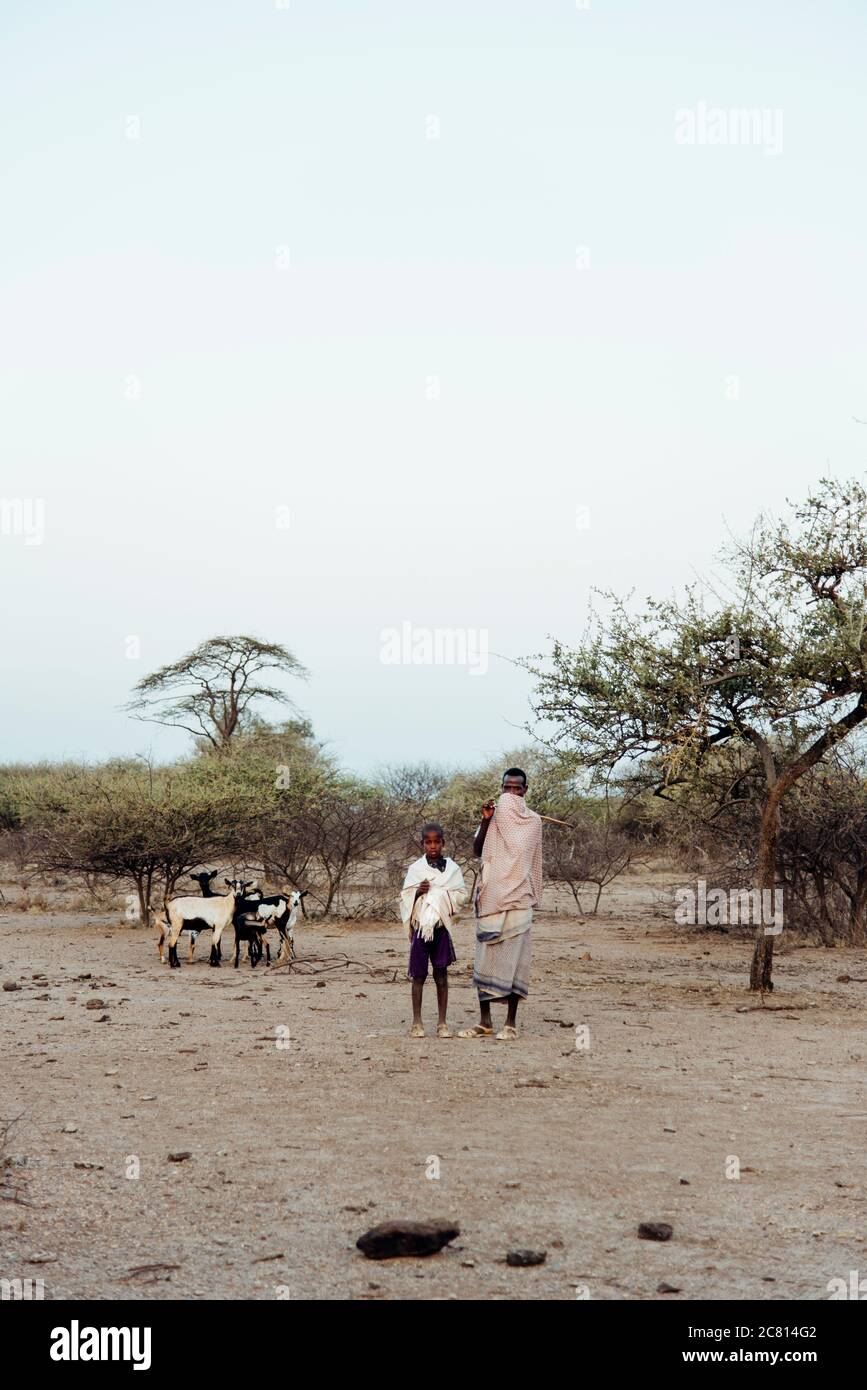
xmin=156 ymin=869 xmax=307 ymax=969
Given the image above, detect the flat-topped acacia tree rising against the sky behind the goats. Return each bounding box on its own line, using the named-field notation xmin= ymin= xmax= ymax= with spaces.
xmin=126 ymin=635 xmax=307 ymax=752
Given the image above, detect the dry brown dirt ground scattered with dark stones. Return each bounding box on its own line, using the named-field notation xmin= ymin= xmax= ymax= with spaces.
xmin=0 ymin=873 xmax=867 ymax=1300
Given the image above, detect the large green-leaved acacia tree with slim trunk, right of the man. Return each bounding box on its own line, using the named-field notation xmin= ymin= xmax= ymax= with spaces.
xmin=522 ymin=478 xmax=867 ymax=990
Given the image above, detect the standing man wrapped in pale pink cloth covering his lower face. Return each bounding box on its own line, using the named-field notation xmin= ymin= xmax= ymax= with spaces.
xmin=459 ymin=767 xmax=542 ymax=1041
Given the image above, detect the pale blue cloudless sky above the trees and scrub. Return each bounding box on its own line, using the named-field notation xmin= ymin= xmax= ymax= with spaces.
xmin=0 ymin=0 xmax=867 ymax=773
